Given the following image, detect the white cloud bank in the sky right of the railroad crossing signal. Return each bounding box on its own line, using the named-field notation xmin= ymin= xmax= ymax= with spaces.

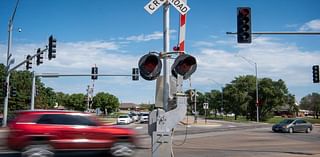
xmin=193 ymin=37 xmax=320 ymax=100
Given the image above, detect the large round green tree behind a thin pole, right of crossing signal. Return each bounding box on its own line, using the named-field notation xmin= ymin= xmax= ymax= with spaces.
xmin=223 ymin=75 xmax=297 ymax=120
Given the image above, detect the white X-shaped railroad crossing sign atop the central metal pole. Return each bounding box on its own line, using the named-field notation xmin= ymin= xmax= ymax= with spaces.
xmin=144 ymin=0 xmax=190 ymax=15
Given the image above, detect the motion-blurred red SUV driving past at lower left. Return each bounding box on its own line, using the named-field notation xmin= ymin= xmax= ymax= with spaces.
xmin=7 ymin=110 xmax=136 ymax=156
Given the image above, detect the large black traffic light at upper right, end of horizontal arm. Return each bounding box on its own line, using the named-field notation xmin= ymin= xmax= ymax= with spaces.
xmin=237 ymin=7 xmax=251 ymax=43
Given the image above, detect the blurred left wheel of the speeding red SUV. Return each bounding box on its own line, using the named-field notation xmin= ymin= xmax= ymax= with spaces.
xmin=21 ymin=144 xmax=54 ymax=157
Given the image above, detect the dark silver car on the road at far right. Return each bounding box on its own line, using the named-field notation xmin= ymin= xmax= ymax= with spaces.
xmin=272 ymin=118 xmax=313 ymax=133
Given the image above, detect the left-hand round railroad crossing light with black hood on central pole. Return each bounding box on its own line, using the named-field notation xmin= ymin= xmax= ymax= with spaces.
xmin=139 ymin=53 xmax=162 ymax=81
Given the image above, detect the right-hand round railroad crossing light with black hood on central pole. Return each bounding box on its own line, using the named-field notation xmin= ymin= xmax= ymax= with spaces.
xmin=171 ymin=54 xmax=197 ymax=80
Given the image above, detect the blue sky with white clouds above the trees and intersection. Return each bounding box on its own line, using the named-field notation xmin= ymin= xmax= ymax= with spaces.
xmin=0 ymin=0 xmax=320 ymax=103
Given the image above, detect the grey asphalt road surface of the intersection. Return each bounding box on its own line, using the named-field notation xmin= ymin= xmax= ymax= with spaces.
xmin=0 ymin=117 xmax=320 ymax=157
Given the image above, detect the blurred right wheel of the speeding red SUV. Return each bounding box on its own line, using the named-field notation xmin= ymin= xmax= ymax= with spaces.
xmin=110 ymin=142 xmax=135 ymax=157
